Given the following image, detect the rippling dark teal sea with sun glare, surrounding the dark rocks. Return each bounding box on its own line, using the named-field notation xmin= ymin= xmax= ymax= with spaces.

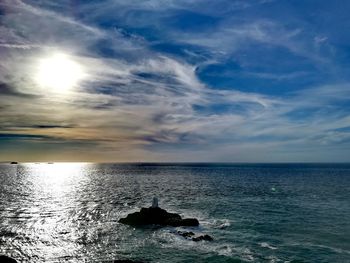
xmin=0 ymin=163 xmax=350 ymax=263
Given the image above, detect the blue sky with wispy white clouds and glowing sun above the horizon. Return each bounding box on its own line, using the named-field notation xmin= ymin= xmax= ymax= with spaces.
xmin=0 ymin=0 xmax=350 ymax=162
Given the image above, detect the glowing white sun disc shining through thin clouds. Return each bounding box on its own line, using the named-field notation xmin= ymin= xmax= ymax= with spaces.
xmin=36 ymin=53 xmax=84 ymax=92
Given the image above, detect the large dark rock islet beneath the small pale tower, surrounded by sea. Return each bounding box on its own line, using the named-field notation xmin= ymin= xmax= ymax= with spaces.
xmin=119 ymin=207 xmax=199 ymax=227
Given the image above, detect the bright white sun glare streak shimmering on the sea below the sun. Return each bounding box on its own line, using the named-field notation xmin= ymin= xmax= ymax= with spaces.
xmin=13 ymin=163 xmax=89 ymax=261
